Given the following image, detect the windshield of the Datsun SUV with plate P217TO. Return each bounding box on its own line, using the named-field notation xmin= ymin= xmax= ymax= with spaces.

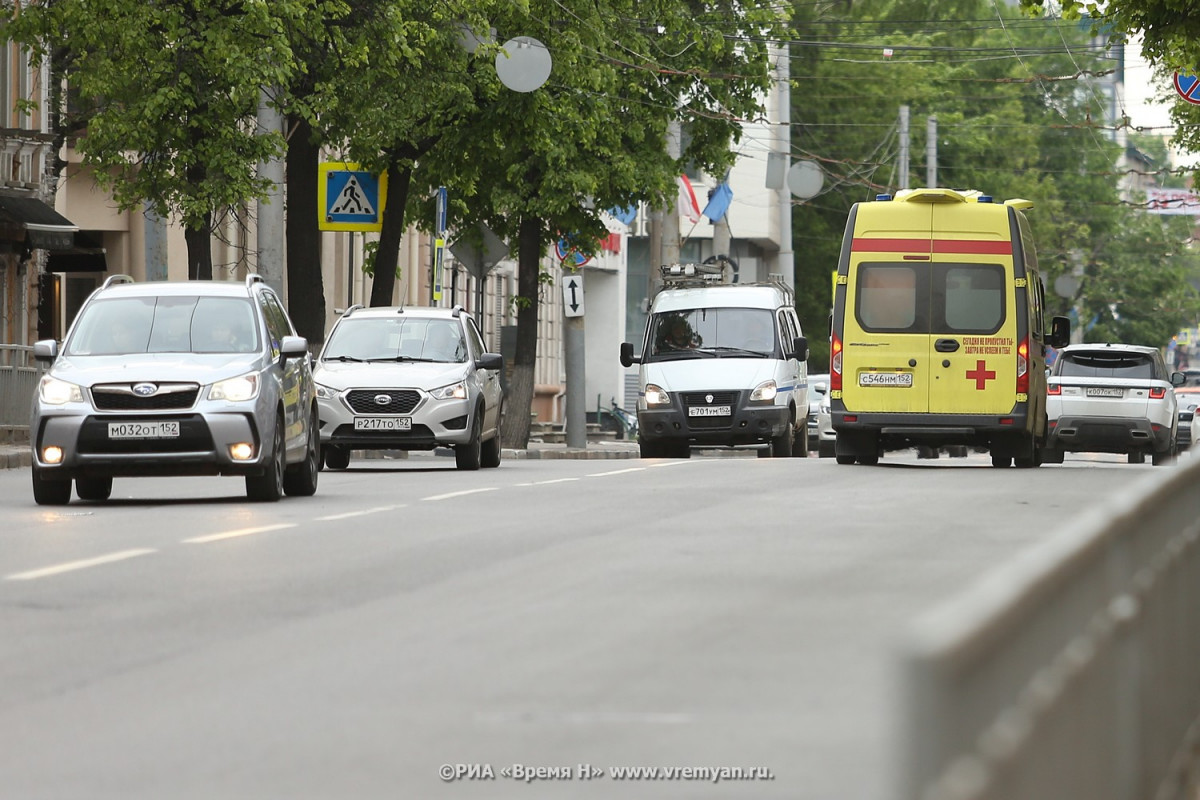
xmin=322 ymin=315 xmax=467 ymax=363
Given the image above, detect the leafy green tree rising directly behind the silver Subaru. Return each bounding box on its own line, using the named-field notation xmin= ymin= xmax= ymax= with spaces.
xmin=0 ymin=0 xmax=323 ymax=278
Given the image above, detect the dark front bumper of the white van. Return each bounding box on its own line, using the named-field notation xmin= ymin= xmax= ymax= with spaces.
xmin=637 ymin=391 xmax=791 ymax=446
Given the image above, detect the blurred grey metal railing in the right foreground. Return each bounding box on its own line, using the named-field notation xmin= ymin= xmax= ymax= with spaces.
xmin=900 ymin=459 xmax=1200 ymax=800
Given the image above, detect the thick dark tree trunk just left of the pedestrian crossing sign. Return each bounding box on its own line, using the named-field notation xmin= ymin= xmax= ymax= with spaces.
xmin=284 ymin=118 xmax=325 ymax=350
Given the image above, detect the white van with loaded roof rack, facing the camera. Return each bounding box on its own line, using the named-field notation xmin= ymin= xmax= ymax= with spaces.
xmin=620 ymin=264 xmax=809 ymax=458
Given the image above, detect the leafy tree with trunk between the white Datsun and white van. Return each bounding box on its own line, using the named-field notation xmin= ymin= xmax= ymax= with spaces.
xmin=421 ymin=0 xmax=785 ymax=447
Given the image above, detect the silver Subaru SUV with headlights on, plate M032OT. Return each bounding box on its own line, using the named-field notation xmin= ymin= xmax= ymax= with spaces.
xmin=29 ymin=275 xmax=320 ymax=505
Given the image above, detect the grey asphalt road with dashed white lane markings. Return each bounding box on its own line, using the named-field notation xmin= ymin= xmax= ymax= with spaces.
xmin=0 ymin=456 xmax=1174 ymax=800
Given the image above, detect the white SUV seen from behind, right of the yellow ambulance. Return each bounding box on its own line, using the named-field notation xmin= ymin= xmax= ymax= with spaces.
xmin=1043 ymin=344 xmax=1184 ymax=464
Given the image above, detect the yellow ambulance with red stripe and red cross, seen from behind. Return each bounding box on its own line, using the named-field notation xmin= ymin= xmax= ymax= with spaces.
xmin=829 ymin=188 xmax=1070 ymax=467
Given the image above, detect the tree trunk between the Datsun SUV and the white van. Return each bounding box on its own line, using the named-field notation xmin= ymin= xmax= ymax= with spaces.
xmin=500 ymin=217 xmax=545 ymax=450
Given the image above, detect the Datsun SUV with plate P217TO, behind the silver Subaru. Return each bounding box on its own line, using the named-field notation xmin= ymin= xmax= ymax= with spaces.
xmin=313 ymin=306 xmax=504 ymax=469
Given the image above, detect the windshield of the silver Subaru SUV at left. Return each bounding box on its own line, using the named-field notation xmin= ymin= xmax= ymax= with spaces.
xmin=65 ymin=296 xmax=259 ymax=355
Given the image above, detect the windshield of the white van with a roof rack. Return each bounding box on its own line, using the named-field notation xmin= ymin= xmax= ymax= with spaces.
xmin=649 ymin=308 xmax=778 ymax=361
